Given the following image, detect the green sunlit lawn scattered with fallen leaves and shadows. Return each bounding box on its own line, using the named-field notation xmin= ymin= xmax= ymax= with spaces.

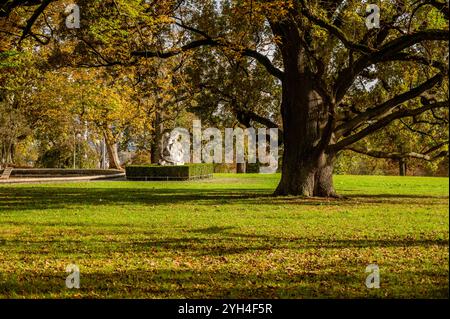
xmin=0 ymin=175 xmax=449 ymax=298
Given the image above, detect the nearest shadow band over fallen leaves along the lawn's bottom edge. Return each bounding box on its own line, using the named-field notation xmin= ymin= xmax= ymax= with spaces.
xmin=0 ymin=267 xmax=448 ymax=299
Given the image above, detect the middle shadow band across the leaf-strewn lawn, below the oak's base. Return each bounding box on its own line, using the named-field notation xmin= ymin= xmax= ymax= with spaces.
xmin=0 ymin=227 xmax=449 ymax=257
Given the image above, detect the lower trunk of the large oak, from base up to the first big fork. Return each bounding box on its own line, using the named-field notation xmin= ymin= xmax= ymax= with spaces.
xmin=275 ymin=70 xmax=336 ymax=197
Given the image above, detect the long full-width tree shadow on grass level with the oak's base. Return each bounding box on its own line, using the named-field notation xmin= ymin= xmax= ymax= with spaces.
xmin=0 ymin=187 xmax=448 ymax=213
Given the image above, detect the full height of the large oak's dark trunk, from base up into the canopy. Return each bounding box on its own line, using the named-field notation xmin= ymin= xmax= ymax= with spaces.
xmin=272 ymin=21 xmax=336 ymax=197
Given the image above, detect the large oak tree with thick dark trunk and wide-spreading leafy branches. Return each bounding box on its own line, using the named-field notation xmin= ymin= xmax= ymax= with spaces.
xmin=2 ymin=0 xmax=449 ymax=196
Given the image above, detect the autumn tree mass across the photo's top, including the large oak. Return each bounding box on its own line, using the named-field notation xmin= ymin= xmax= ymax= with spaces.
xmin=0 ymin=0 xmax=448 ymax=196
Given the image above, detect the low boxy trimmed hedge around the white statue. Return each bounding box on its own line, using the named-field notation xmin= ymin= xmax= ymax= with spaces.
xmin=125 ymin=164 xmax=214 ymax=181
